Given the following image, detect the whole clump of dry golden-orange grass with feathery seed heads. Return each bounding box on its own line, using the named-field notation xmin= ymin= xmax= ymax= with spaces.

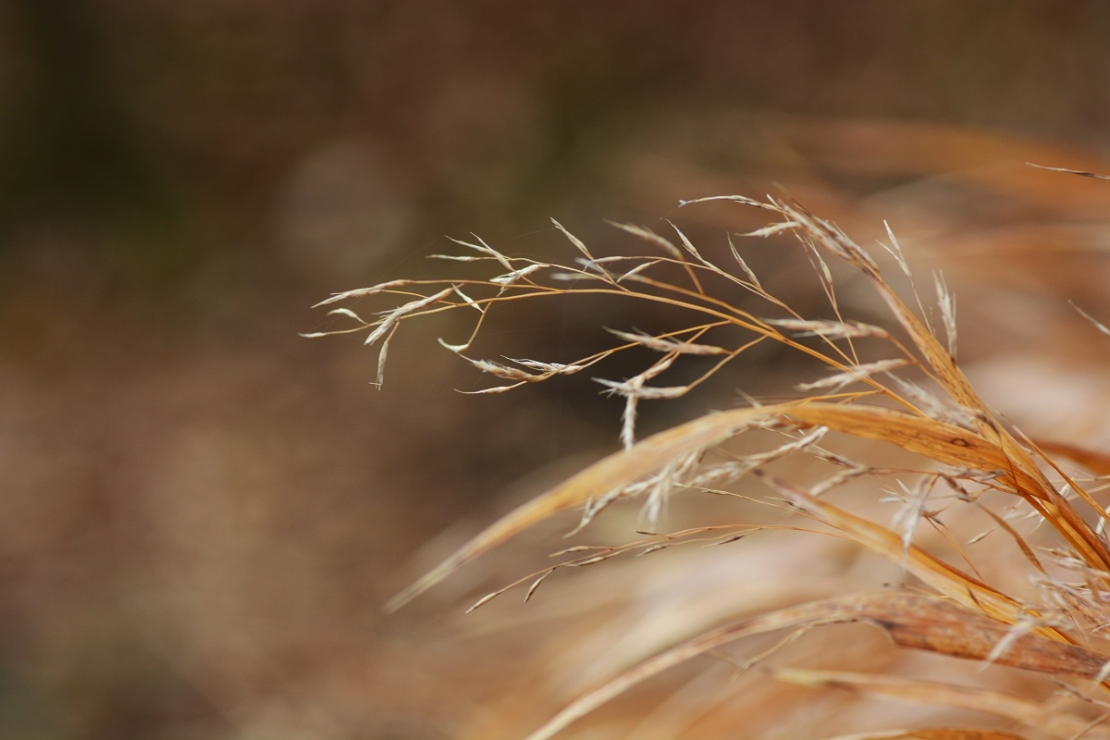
xmin=308 ymin=188 xmax=1110 ymax=740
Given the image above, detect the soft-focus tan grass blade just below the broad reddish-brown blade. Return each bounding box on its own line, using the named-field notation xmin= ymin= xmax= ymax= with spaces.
xmin=773 ymin=668 xmax=1110 ymax=738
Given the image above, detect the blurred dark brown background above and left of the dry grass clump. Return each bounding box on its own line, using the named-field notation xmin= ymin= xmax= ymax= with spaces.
xmin=0 ymin=0 xmax=1110 ymax=740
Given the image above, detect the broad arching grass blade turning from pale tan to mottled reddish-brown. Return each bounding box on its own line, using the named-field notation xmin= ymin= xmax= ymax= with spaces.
xmin=526 ymin=591 xmax=1106 ymax=740
